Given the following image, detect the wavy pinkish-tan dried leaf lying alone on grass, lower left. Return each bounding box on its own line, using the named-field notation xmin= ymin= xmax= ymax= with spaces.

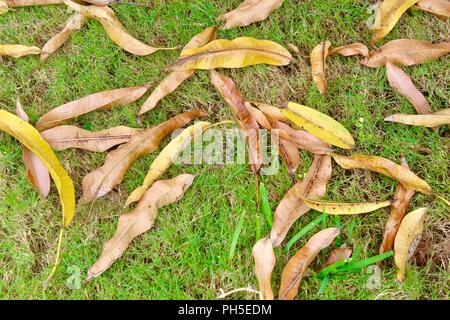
xmin=87 ymin=174 xmax=195 ymax=280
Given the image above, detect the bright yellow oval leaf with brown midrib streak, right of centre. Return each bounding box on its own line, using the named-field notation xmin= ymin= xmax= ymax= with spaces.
xmin=281 ymin=102 xmax=355 ymax=149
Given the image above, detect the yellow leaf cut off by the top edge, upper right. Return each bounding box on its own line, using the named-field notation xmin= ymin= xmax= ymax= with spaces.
xmin=372 ymin=0 xmax=419 ymax=43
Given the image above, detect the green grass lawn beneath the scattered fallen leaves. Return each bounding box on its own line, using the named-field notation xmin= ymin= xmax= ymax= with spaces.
xmin=0 ymin=0 xmax=450 ymax=299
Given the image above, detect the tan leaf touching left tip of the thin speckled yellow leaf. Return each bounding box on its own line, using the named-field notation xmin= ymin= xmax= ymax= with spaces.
xmin=270 ymin=155 xmax=332 ymax=247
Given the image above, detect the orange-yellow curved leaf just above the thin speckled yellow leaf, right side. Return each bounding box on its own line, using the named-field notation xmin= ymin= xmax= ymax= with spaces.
xmin=330 ymin=153 xmax=432 ymax=194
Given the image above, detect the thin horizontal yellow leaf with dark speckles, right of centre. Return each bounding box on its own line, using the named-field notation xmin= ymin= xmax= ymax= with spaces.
xmin=300 ymin=196 xmax=391 ymax=215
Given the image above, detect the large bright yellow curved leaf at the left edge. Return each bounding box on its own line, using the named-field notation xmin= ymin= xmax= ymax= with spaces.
xmin=0 ymin=110 xmax=75 ymax=227
